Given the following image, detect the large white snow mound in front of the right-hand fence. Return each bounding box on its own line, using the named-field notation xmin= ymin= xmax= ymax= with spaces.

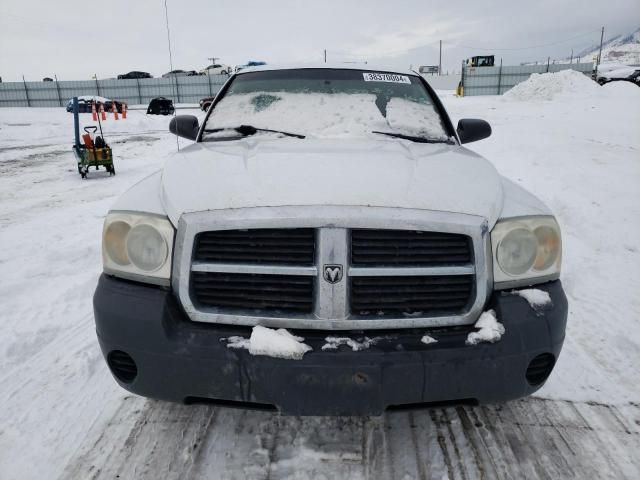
xmin=503 ymin=70 xmax=601 ymax=101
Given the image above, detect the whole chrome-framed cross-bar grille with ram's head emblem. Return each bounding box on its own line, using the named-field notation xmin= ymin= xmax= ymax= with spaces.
xmin=172 ymin=206 xmax=489 ymax=330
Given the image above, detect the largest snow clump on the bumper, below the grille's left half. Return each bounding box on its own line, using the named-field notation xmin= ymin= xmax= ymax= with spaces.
xmin=227 ymin=325 xmax=313 ymax=360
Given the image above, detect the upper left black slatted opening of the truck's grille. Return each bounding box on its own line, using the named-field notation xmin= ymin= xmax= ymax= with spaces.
xmin=193 ymin=228 xmax=315 ymax=265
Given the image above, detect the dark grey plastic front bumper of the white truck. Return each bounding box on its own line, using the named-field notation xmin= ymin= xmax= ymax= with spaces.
xmin=93 ymin=275 xmax=567 ymax=415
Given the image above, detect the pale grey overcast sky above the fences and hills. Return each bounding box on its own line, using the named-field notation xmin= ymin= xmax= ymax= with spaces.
xmin=0 ymin=0 xmax=640 ymax=81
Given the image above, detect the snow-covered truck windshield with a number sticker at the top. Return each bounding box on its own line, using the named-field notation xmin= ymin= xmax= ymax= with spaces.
xmin=203 ymin=68 xmax=448 ymax=141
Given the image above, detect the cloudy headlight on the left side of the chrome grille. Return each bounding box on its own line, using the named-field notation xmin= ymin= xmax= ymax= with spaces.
xmin=102 ymin=212 xmax=175 ymax=285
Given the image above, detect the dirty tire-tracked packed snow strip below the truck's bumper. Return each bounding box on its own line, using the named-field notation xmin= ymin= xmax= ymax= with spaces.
xmin=60 ymin=397 xmax=640 ymax=480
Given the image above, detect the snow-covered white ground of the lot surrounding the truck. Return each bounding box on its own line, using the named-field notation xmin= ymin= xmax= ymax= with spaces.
xmin=0 ymin=77 xmax=640 ymax=479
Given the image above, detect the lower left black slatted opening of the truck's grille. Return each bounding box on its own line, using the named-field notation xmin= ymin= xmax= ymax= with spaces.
xmin=191 ymin=272 xmax=313 ymax=314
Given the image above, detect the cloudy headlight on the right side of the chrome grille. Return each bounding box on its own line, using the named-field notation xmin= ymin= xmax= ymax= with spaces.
xmin=491 ymin=217 xmax=562 ymax=289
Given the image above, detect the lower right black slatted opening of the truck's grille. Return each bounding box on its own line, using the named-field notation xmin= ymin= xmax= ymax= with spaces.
xmin=350 ymin=275 xmax=475 ymax=317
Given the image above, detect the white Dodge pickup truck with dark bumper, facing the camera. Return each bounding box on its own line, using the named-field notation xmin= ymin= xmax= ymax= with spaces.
xmin=93 ymin=64 xmax=567 ymax=415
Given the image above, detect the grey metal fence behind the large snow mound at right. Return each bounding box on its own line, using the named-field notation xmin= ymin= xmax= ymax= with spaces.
xmin=462 ymin=63 xmax=593 ymax=96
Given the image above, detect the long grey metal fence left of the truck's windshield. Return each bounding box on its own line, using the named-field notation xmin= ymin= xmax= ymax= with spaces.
xmin=0 ymin=75 xmax=229 ymax=107
